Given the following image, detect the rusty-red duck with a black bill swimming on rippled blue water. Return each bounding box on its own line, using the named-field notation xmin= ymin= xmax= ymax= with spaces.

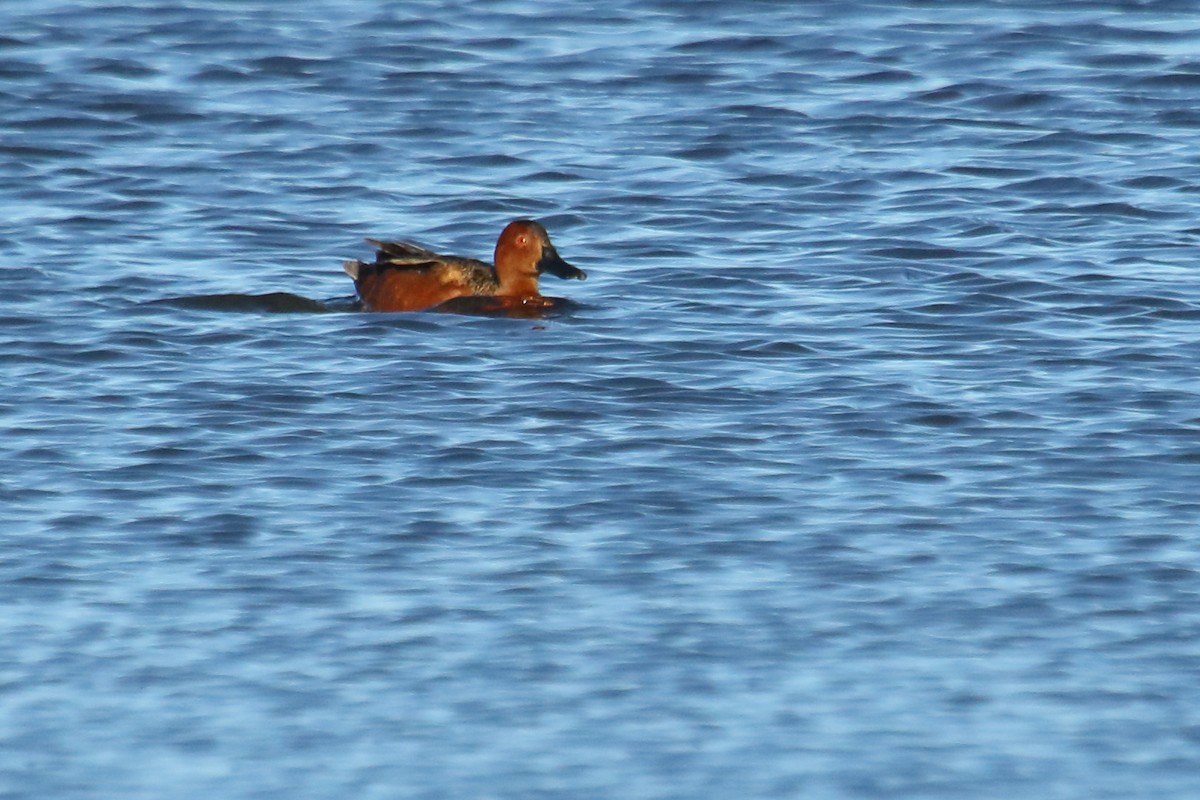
xmin=343 ymin=219 xmax=588 ymax=313
